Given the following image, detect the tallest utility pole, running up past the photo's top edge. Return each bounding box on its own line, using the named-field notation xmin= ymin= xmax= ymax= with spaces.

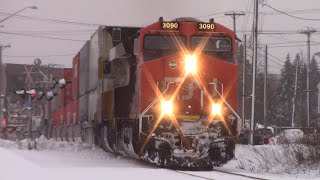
xmin=249 ymin=0 xmax=259 ymax=145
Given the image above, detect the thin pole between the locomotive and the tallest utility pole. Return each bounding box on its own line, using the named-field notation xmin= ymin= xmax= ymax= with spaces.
xmin=242 ymin=34 xmax=247 ymax=127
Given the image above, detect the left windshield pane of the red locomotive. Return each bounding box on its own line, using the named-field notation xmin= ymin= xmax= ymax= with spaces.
xmin=143 ymin=35 xmax=187 ymax=61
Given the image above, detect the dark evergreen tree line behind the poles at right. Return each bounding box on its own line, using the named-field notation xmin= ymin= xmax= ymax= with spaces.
xmin=238 ymin=45 xmax=320 ymax=127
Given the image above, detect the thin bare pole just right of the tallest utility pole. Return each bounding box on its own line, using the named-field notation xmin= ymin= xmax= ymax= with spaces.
xmin=263 ymin=46 xmax=268 ymax=135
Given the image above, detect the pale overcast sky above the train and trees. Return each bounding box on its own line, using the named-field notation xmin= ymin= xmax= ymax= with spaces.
xmin=0 ymin=0 xmax=320 ymax=72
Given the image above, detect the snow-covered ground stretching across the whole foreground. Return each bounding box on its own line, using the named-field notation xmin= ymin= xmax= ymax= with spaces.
xmin=0 ymin=138 xmax=320 ymax=180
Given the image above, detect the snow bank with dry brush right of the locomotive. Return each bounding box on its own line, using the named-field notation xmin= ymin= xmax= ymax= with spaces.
xmin=224 ymin=144 xmax=320 ymax=178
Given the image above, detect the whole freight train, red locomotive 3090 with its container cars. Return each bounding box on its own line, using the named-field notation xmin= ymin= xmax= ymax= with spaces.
xmin=50 ymin=17 xmax=240 ymax=168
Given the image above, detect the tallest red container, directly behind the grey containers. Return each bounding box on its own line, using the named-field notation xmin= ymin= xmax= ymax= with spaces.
xmin=71 ymin=52 xmax=80 ymax=100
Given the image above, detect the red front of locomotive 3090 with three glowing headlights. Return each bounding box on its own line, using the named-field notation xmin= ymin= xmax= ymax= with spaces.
xmin=138 ymin=18 xmax=239 ymax=167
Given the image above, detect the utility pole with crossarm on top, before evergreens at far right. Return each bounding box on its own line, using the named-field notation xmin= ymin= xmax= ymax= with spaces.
xmin=301 ymin=29 xmax=317 ymax=127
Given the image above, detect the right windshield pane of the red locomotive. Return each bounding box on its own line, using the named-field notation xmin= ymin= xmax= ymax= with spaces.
xmin=190 ymin=36 xmax=233 ymax=62
